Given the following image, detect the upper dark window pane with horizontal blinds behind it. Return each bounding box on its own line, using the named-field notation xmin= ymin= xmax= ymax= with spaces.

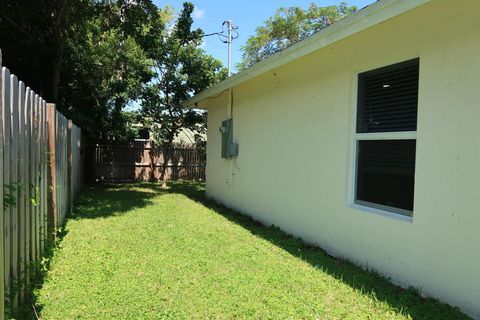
xmin=357 ymin=59 xmax=419 ymax=133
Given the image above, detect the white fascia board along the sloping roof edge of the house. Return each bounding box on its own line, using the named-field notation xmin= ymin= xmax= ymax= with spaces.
xmin=183 ymin=0 xmax=433 ymax=108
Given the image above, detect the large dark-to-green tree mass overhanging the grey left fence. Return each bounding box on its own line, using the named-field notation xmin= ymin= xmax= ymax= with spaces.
xmin=0 ymin=0 xmax=164 ymax=140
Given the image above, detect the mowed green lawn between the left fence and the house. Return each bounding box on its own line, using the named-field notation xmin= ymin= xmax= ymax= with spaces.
xmin=32 ymin=183 xmax=467 ymax=320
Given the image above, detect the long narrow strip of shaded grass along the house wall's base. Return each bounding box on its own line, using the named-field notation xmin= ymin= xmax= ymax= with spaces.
xmin=163 ymin=182 xmax=470 ymax=320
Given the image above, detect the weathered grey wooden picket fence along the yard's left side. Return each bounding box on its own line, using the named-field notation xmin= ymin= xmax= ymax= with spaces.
xmin=0 ymin=53 xmax=82 ymax=319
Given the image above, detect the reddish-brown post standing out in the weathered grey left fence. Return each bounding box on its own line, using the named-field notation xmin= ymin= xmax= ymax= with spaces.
xmin=47 ymin=103 xmax=58 ymax=237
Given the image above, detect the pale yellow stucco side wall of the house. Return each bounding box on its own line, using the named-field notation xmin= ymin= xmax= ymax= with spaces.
xmin=207 ymin=0 xmax=480 ymax=317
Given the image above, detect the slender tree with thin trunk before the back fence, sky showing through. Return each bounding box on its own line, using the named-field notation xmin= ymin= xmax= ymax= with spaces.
xmin=142 ymin=2 xmax=227 ymax=186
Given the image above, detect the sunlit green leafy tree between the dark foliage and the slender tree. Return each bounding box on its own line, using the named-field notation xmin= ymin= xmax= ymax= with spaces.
xmin=59 ymin=0 xmax=164 ymax=140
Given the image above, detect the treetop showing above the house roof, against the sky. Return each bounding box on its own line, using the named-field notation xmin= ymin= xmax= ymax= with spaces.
xmin=236 ymin=2 xmax=357 ymax=70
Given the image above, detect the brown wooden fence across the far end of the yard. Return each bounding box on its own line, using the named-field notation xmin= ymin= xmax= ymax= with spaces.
xmin=94 ymin=141 xmax=206 ymax=182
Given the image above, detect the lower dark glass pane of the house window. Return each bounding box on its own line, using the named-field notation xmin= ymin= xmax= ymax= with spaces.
xmin=356 ymin=140 xmax=416 ymax=211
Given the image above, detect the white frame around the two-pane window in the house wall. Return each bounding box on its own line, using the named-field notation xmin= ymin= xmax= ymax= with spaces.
xmin=347 ymin=56 xmax=420 ymax=223
